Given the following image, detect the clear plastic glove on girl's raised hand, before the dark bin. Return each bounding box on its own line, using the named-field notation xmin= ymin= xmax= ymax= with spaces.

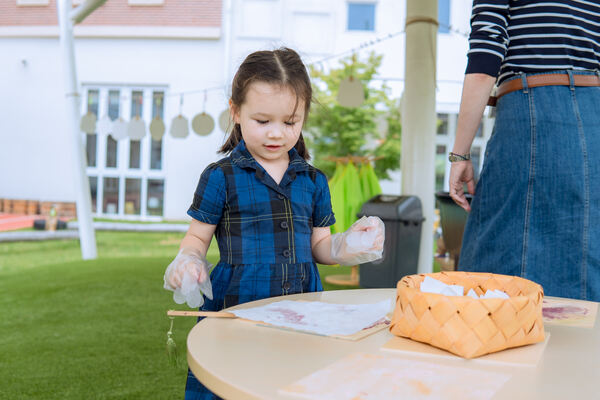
xmin=331 ymin=217 xmax=385 ymax=265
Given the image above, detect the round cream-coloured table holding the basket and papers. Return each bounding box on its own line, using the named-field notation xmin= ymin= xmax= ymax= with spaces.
xmin=187 ymin=289 xmax=600 ymax=400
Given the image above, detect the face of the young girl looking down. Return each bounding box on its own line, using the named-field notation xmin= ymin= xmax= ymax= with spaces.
xmin=232 ymin=82 xmax=304 ymax=164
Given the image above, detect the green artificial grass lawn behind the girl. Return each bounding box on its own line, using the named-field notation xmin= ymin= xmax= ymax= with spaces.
xmin=0 ymin=231 xmax=364 ymax=400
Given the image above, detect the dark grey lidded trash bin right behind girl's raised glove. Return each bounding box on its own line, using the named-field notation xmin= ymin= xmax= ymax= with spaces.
xmin=358 ymin=194 xmax=424 ymax=288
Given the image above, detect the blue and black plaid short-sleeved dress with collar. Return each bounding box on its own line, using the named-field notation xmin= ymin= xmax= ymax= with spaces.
xmin=185 ymin=141 xmax=335 ymax=400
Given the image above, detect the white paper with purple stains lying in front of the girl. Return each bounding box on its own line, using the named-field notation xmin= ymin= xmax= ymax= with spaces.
xmin=231 ymin=300 xmax=391 ymax=336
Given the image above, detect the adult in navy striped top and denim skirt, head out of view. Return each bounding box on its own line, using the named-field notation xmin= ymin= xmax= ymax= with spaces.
xmin=450 ymin=0 xmax=600 ymax=301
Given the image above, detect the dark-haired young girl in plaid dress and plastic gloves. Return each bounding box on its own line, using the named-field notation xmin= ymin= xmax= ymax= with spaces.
xmin=165 ymin=48 xmax=384 ymax=399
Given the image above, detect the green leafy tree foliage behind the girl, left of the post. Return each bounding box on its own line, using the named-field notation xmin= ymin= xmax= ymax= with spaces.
xmin=305 ymin=53 xmax=401 ymax=179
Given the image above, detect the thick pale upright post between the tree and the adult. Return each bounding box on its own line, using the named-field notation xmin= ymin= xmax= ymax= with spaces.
xmin=401 ymin=0 xmax=438 ymax=273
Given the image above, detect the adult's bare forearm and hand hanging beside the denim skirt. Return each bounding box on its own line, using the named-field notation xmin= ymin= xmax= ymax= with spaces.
xmin=449 ymin=73 xmax=496 ymax=211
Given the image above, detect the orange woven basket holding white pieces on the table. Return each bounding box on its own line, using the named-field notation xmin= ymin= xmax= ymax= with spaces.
xmin=390 ymin=271 xmax=544 ymax=358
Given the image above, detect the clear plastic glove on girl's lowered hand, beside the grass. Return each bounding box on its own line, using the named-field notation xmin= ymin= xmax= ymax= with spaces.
xmin=164 ymin=248 xmax=213 ymax=308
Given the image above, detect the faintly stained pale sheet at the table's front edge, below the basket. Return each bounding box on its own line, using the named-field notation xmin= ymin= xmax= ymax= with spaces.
xmin=280 ymin=353 xmax=510 ymax=400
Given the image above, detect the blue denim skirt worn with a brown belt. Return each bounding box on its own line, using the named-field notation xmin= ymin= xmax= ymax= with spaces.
xmin=458 ymin=71 xmax=600 ymax=301
